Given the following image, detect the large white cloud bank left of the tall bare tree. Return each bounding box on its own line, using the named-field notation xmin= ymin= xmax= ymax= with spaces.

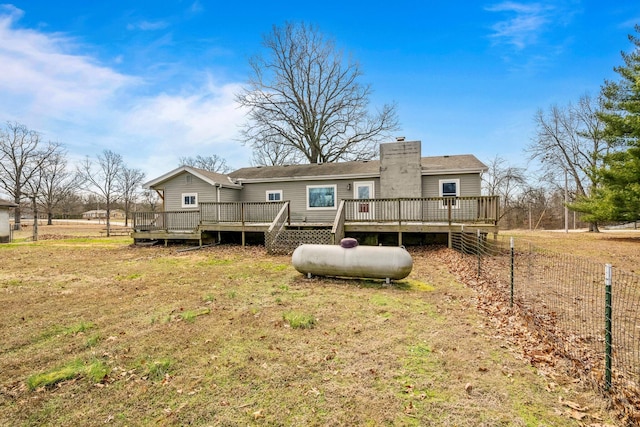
xmin=0 ymin=7 xmax=249 ymax=177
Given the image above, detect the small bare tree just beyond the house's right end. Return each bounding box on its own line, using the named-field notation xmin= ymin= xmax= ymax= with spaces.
xmin=482 ymin=156 xmax=526 ymax=227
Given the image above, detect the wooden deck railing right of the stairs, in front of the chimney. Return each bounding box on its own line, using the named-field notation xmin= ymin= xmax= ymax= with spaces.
xmin=344 ymin=196 xmax=498 ymax=224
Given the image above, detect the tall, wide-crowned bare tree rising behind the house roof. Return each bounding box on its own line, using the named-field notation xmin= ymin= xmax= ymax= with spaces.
xmin=236 ymin=23 xmax=398 ymax=163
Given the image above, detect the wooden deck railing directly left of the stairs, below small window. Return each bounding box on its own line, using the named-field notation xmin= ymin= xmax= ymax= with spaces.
xmin=200 ymin=202 xmax=287 ymax=224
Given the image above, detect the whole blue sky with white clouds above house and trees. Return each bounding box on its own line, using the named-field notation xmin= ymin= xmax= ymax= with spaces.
xmin=0 ymin=0 xmax=640 ymax=179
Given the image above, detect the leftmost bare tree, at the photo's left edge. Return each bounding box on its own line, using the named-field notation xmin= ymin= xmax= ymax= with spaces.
xmin=0 ymin=122 xmax=60 ymax=230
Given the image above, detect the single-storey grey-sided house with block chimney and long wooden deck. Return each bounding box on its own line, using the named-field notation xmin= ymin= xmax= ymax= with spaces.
xmin=133 ymin=140 xmax=498 ymax=252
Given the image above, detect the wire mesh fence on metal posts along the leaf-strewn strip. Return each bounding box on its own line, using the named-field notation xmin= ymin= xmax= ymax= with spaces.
xmin=451 ymin=233 xmax=640 ymax=413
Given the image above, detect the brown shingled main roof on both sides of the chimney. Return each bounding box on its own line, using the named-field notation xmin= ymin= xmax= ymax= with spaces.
xmin=229 ymin=154 xmax=487 ymax=182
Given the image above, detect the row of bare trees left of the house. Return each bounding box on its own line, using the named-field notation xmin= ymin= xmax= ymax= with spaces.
xmin=0 ymin=122 xmax=154 ymax=239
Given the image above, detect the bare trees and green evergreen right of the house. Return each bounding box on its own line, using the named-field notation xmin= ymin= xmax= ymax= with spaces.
xmin=484 ymin=26 xmax=640 ymax=231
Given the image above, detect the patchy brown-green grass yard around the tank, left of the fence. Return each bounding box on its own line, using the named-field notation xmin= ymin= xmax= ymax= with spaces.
xmin=0 ymin=224 xmax=638 ymax=426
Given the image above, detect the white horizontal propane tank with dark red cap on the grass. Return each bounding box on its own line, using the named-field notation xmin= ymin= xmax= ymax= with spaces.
xmin=291 ymin=239 xmax=413 ymax=281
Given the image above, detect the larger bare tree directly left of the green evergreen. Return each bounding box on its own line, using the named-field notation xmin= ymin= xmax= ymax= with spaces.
xmin=527 ymin=95 xmax=612 ymax=231
